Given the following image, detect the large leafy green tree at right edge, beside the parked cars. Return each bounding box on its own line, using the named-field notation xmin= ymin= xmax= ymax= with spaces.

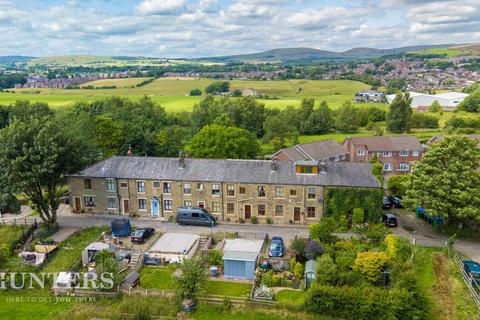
xmin=405 ymin=136 xmax=480 ymax=224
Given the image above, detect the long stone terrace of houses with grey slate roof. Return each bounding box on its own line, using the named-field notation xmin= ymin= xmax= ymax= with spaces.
xmin=69 ymin=156 xmax=379 ymax=224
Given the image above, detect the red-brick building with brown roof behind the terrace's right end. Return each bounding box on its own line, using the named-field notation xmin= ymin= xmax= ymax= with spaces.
xmin=343 ymin=136 xmax=423 ymax=175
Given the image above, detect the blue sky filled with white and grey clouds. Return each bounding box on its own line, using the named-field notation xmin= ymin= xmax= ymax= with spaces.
xmin=0 ymin=0 xmax=480 ymax=58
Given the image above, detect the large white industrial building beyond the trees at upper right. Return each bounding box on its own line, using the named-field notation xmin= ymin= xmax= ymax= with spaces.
xmin=387 ymin=91 xmax=468 ymax=111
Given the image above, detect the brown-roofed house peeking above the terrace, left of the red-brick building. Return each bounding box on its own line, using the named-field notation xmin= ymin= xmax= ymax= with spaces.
xmin=270 ymin=139 xmax=349 ymax=161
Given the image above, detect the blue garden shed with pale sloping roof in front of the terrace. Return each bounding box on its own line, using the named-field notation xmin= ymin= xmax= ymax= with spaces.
xmin=222 ymin=239 xmax=263 ymax=280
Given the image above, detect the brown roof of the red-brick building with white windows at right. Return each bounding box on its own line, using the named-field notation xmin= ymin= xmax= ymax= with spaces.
xmin=348 ymin=136 xmax=423 ymax=151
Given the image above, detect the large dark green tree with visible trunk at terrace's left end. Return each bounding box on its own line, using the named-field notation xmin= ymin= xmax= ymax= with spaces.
xmin=0 ymin=114 xmax=87 ymax=226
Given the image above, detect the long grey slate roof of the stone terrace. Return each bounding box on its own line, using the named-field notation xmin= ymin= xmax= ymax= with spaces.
xmin=72 ymin=156 xmax=379 ymax=188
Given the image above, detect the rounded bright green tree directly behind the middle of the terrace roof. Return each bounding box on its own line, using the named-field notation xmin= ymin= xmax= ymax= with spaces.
xmin=187 ymin=124 xmax=260 ymax=159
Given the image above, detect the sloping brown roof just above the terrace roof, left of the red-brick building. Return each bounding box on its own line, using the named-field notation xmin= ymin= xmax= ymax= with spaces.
xmin=277 ymin=139 xmax=348 ymax=161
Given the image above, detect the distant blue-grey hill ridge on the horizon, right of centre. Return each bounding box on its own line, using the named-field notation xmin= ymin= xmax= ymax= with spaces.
xmin=199 ymin=44 xmax=458 ymax=62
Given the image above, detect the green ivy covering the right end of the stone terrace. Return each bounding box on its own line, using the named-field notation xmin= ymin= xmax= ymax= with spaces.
xmin=325 ymin=188 xmax=383 ymax=222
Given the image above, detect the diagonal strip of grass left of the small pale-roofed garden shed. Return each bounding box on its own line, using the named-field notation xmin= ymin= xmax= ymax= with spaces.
xmin=42 ymin=227 xmax=104 ymax=272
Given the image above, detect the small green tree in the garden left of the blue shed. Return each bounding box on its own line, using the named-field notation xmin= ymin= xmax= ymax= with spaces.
xmin=175 ymin=258 xmax=208 ymax=303
